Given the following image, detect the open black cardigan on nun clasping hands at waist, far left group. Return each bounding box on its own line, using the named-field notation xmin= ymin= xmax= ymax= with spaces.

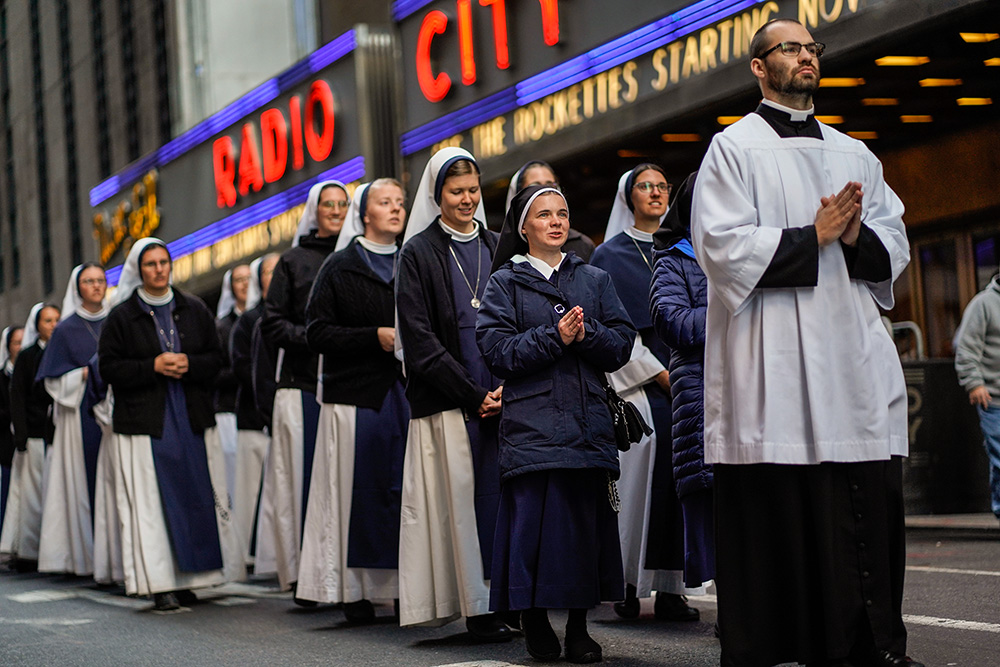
xmin=98 ymin=289 xmax=222 ymax=438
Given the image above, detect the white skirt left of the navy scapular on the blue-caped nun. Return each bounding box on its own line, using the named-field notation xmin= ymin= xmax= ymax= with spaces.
xmin=38 ymin=401 xmax=94 ymax=575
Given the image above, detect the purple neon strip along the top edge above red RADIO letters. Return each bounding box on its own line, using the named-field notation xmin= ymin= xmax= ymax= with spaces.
xmin=90 ymin=30 xmax=357 ymax=206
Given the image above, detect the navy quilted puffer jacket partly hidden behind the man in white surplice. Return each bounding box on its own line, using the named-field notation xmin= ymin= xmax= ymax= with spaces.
xmin=649 ymin=248 xmax=712 ymax=498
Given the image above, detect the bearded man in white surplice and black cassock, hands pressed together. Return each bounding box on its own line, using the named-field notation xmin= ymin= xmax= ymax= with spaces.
xmin=692 ymin=19 xmax=918 ymax=665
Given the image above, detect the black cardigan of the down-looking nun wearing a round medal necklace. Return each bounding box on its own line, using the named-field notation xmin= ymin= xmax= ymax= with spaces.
xmin=396 ymin=220 xmax=499 ymax=419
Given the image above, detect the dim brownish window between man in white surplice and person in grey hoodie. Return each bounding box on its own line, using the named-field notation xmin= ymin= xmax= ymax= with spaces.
xmin=918 ymin=239 xmax=962 ymax=357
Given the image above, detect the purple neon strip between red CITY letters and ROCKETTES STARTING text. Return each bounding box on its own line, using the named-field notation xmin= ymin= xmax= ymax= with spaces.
xmin=399 ymin=0 xmax=759 ymax=155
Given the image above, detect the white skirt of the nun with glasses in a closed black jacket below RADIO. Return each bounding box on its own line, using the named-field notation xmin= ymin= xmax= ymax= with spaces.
xmin=254 ymin=388 xmax=305 ymax=591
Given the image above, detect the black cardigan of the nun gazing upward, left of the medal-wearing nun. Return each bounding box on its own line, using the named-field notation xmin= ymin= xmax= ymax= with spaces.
xmin=306 ymin=241 xmax=402 ymax=410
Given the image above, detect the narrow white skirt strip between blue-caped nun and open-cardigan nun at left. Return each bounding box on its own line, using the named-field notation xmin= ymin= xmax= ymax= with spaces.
xmin=94 ymin=423 xmax=125 ymax=584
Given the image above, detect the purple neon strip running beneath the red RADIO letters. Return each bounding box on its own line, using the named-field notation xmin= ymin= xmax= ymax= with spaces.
xmin=107 ymin=155 xmax=365 ymax=285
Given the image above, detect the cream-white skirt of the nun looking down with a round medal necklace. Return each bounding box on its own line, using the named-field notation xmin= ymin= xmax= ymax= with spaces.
xmin=399 ymin=409 xmax=490 ymax=626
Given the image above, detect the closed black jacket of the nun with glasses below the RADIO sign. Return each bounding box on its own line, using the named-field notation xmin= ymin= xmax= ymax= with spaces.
xmin=260 ymin=231 xmax=337 ymax=392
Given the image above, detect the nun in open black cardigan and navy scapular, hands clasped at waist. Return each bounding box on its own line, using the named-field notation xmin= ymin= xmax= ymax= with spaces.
xmin=98 ymin=238 xmax=244 ymax=611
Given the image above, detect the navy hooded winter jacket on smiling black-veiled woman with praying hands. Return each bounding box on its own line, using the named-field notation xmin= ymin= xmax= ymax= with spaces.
xmin=476 ymin=255 xmax=636 ymax=481
